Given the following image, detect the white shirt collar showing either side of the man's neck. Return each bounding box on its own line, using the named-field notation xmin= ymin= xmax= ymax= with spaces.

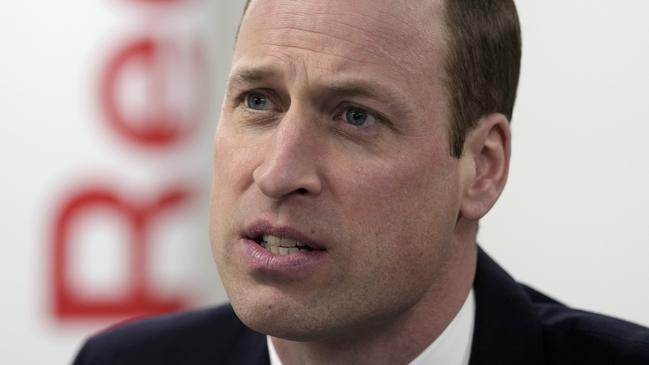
xmin=266 ymin=289 xmax=475 ymax=365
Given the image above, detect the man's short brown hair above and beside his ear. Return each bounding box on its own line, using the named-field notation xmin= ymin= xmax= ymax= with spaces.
xmin=239 ymin=0 xmax=522 ymax=158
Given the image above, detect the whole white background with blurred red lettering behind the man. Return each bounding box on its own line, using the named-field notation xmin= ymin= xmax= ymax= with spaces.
xmin=0 ymin=0 xmax=649 ymax=364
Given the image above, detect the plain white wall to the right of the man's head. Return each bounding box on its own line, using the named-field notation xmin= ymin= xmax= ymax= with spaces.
xmin=479 ymin=0 xmax=649 ymax=325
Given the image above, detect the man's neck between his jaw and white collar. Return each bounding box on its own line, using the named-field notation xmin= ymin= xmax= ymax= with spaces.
xmin=272 ymin=220 xmax=477 ymax=365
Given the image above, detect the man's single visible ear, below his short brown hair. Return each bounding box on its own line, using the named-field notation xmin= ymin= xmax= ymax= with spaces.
xmin=460 ymin=113 xmax=511 ymax=220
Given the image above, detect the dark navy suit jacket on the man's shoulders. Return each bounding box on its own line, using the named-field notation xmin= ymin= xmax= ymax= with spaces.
xmin=74 ymin=250 xmax=649 ymax=365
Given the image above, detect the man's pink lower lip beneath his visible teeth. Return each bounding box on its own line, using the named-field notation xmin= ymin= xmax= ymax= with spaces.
xmin=241 ymin=238 xmax=326 ymax=279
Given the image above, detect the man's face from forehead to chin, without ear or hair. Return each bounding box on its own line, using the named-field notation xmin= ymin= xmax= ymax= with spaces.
xmin=210 ymin=0 xmax=463 ymax=340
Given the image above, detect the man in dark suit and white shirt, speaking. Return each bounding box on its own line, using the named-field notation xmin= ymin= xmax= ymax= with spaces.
xmin=71 ymin=0 xmax=649 ymax=365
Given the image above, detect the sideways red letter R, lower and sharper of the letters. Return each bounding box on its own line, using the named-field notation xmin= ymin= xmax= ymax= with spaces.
xmin=53 ymin=188 xmax=188 ymax=319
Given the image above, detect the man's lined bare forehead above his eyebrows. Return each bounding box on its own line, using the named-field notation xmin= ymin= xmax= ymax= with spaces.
xmin=235 ymin=0 xmax=445 ymax=75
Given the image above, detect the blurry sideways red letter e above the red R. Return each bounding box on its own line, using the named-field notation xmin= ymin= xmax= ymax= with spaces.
xmin=100 ymin=37 xmax=209 ymax=147
